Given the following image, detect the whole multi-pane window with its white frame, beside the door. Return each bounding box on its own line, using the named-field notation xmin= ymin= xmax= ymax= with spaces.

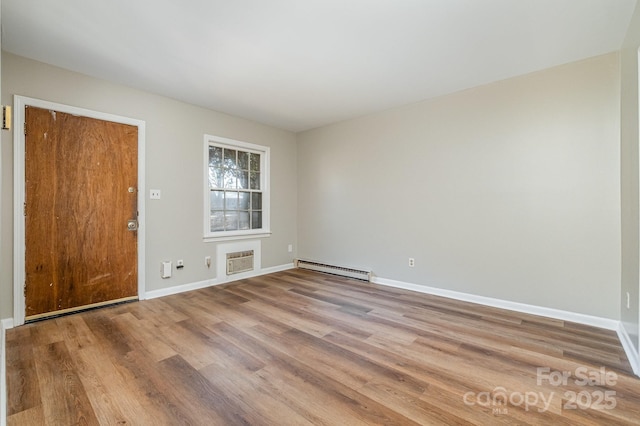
xmin=204 ymin=135 xmax=270 ymax=240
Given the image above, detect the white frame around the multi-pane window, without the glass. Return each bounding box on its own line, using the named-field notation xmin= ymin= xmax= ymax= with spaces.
xmin=203 ymin=134 xmax=271 ymax=242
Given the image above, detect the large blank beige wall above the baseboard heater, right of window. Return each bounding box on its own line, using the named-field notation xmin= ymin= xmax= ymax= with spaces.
xmin=298 ymin=54 xmax=621 ymax=319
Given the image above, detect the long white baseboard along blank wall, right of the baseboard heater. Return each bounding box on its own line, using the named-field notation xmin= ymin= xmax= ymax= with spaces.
xmin=372 ymin=277 xmax=620 ymax=330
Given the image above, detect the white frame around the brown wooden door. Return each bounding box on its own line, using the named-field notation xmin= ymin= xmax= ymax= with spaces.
xmin=13 ymin=95 xmax=146 ymax=326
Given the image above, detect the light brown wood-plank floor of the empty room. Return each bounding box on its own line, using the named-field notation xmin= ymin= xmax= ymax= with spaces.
xmin=7 ymin=270 xmax=640 ymax=426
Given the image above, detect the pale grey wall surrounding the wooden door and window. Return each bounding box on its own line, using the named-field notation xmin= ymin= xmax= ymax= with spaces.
xmin=0 ymin=52 xmax=297 ymax=318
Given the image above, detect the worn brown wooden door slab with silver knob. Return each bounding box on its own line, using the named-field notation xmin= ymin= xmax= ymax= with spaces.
xmin=25 ymin=106 xmax=138 ymax=320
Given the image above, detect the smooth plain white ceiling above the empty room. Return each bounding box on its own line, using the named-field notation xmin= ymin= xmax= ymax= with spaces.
xmin=1 ymin=0 xmax=636 ymax=132
